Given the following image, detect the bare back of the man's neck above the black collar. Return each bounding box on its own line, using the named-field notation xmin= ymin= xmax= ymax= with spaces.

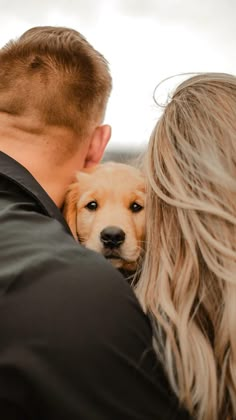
xmin=0 ymin=113 xmax=83 ymax=208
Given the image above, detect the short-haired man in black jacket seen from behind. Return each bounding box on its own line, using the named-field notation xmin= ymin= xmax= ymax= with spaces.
xmin=0 ymin=27 xmax=189 ymax=420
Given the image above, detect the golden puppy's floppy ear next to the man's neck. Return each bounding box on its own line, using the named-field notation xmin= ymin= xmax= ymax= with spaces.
xmin=63 ymin=182 xmax=79 ymax=241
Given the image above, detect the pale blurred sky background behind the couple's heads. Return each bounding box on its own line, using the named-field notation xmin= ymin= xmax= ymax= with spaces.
xmin=0 ymin=0 xmax=236 ymax=160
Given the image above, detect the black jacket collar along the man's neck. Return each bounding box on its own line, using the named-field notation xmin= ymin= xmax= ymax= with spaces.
xmin=0 ymin=151 xmax=71 ymax=234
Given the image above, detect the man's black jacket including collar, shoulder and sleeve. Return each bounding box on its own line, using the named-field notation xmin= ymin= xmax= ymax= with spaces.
xmin=0 ymin=152 xmax=190 ymax=420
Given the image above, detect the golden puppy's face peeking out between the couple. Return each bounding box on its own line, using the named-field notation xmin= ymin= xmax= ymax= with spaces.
xmin=64 ymin=162 xmax=145 ymax=271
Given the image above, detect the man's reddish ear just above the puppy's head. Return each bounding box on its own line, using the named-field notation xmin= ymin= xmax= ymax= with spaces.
xmin=84 ymin=125 xmax=111 ymax=168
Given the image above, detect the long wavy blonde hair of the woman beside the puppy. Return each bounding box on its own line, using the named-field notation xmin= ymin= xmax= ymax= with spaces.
xmin=136 ymin=73 xmax=236 ymax=420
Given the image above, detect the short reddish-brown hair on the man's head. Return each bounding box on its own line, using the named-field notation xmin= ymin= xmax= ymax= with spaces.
xmin=0 ymin=26 xmax=111 ymax=137
